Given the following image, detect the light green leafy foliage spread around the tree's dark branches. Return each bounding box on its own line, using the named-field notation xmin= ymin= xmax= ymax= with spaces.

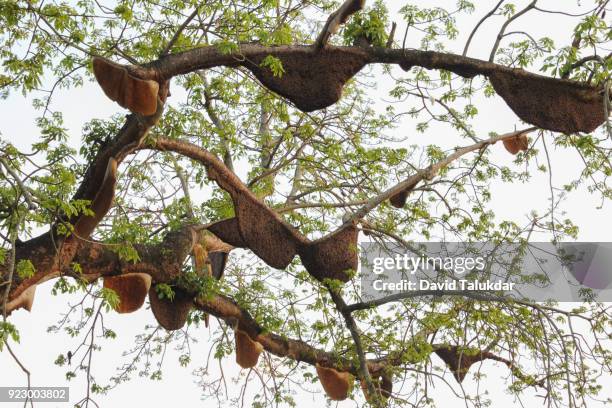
xmin=0 ymin=0 xmax=612 ymax=406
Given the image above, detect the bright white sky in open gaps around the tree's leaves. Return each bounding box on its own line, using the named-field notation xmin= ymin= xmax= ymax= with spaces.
xmin=0 ymin=0 xmax=612 ymax=408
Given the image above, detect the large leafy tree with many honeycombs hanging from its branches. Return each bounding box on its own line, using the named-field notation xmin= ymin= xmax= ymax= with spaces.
xmin=0 ymin=0 xmax=612 ymax=407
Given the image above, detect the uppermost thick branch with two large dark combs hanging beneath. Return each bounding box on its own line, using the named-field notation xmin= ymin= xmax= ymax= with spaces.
xmin=145 ymin=44 xmax=607 ymax=133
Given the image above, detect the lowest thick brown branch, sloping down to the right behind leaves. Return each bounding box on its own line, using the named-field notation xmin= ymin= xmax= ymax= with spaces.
xmin=19 ymin=226 xmax=540 ymax=395
